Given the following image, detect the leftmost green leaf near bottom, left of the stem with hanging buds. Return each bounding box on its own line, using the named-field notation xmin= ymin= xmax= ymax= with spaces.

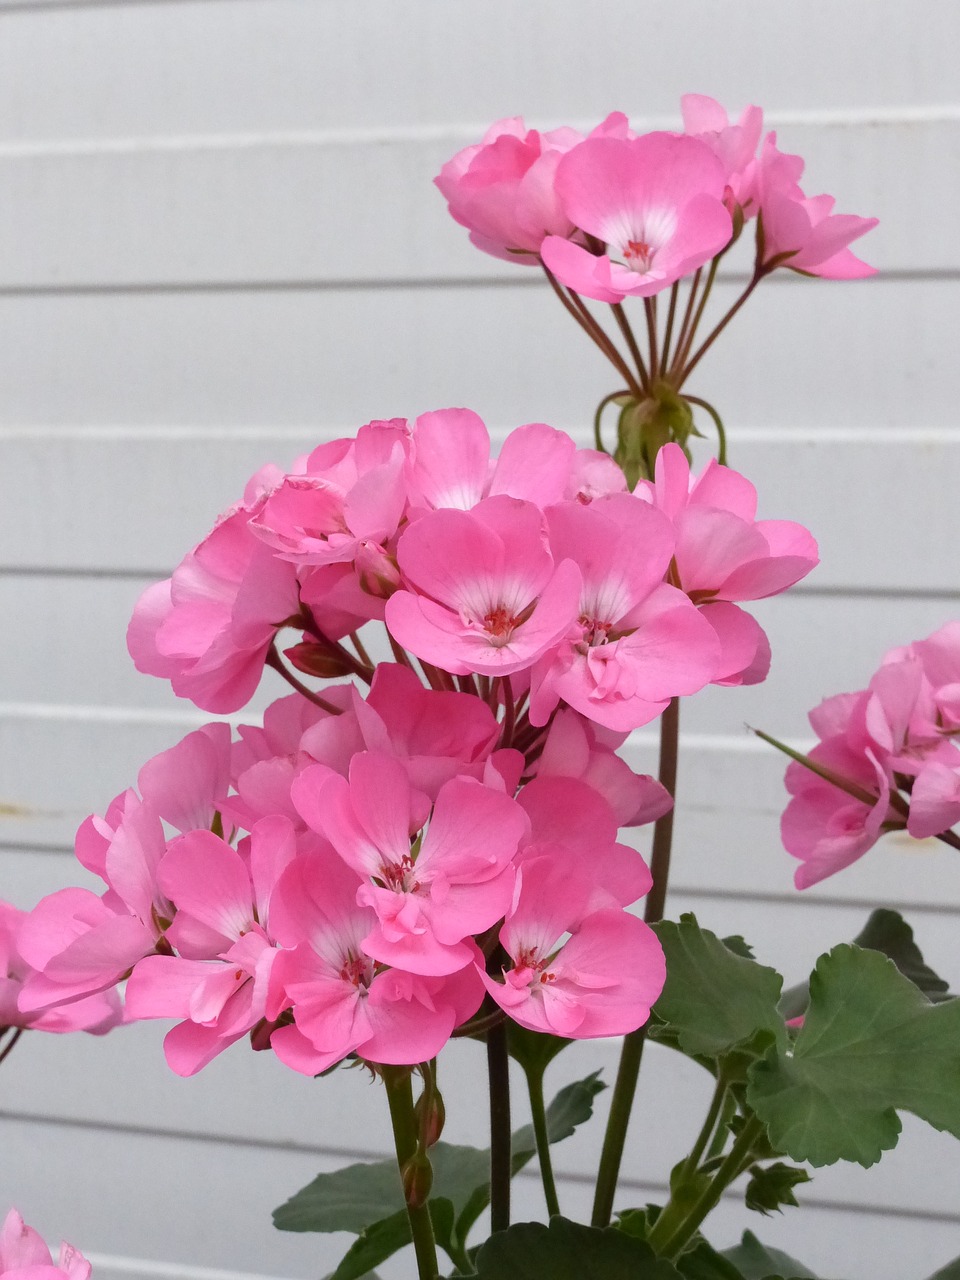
xmin=274 ymin=1160 xmax=406 ymax=1235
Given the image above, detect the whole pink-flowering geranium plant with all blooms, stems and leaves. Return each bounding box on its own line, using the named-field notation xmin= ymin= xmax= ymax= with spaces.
xmin=0 ymin=96 xmax=960 ymax=1280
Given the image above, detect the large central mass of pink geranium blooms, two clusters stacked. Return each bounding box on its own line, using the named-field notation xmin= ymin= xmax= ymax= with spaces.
xmin=13 ymin=410 xmax=817 ymax=1074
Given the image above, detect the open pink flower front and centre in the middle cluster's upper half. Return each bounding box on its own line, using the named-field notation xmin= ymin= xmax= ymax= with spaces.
xmin=387 ymin=497 xmax=580 ymax=676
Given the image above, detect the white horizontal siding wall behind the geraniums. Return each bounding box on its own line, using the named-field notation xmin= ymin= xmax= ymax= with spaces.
xmin=0 ymin=0 xmax=960 ymax=1280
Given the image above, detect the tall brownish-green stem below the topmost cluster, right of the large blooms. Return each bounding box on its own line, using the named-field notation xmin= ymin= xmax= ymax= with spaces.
xmin=591 ymin=698 xmax=680 ymax=1226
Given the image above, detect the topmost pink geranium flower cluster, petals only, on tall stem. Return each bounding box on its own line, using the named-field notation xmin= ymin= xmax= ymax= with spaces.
xmin=435 ymin=93 xmax=877 ymax=290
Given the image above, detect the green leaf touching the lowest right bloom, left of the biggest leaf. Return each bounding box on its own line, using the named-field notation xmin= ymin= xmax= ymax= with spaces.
xmin=654 ymin=915 xmax=787 ymax=1059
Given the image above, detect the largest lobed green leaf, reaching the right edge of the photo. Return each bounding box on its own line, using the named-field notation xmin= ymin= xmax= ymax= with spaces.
xmin=746 ymin=943 xmax=960 ymax=1166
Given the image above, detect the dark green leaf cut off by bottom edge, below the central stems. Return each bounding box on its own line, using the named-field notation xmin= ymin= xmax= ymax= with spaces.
xmin=476 ymin=1217 xmax=680 ymax=1280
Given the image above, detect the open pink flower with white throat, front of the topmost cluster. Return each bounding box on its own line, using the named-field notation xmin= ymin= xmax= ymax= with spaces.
xmin=540 ymin=133 xmax=732 ymax=302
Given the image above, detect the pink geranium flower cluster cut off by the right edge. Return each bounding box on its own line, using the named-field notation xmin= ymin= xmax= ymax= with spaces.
xmin=781 ymin=622 xmax=960 ymax=888
